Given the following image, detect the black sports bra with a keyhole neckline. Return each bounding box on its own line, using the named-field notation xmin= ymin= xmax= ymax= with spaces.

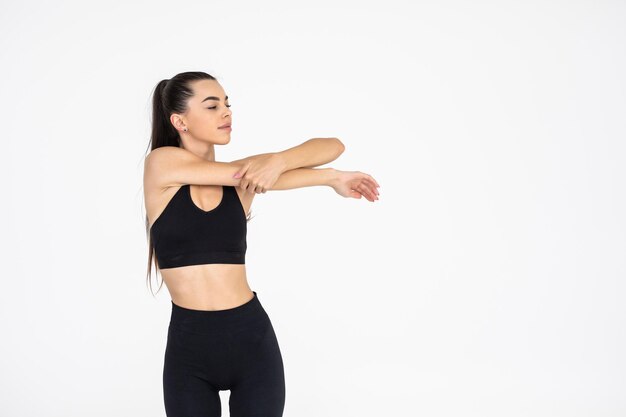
xmin=150 ymin=184 xmax=247 ymax=269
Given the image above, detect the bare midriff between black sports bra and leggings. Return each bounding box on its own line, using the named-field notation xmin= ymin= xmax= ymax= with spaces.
xmin=160 ymin=264 xmax=254 ymax=310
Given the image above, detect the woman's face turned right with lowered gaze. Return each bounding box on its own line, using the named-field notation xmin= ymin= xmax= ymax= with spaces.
xmin=172 ymin=80 xmax=232 ymax=144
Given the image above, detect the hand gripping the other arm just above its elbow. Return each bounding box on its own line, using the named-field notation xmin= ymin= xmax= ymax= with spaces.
xmin=234 ymin=153 xmax=286 ymax=194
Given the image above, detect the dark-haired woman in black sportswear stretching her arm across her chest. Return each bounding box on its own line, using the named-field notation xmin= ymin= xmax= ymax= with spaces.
xmin=144 ymin=72 xmax=378 ymax=417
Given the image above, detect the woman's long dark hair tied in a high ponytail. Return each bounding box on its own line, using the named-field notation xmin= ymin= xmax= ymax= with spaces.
xmin=146 ymin=71 xmax=251 ymax=293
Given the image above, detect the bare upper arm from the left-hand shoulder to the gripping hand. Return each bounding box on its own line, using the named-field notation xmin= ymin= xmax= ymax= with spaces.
xmin=144 ymin=146 xmax=243 ymax=188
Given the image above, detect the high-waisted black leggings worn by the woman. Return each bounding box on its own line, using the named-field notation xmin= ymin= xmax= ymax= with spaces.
xmin=163 ymin=291 xmax=285 ymax=417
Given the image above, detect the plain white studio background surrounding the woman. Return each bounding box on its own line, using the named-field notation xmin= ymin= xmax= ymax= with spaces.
xmin=0 ymin=0 xmax=626 ymax=417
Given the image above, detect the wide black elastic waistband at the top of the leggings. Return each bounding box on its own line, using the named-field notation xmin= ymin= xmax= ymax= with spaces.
xmin=170 ymin=291 xmax=264 ymax=325
